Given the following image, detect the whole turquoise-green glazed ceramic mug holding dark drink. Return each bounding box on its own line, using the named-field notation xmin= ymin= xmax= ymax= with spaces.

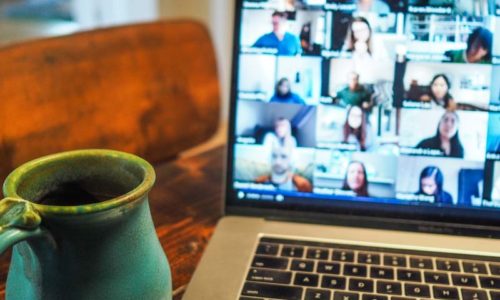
xmin=0 ymin=150 xmax=172 ymax=300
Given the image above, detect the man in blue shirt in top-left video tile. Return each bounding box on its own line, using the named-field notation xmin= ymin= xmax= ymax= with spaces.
xmin=253 ymin=11 xmax=302 ymax=55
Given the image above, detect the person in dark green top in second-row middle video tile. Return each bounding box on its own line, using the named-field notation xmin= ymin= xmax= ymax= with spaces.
xmin=337 ymin=72 xmax=371 ymax=110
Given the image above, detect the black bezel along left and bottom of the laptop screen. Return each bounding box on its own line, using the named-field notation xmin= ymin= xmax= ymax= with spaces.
xmin=224 ymin=0 xmax=500 ymax=237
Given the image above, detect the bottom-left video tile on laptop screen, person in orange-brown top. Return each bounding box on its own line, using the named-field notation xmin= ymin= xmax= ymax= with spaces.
xmin=234 ymin=145 xmax=314 ymax=193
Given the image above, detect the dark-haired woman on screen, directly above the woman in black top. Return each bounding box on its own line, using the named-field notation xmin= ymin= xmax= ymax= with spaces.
xmin=420 ymin=74 xmax=457 ymax=110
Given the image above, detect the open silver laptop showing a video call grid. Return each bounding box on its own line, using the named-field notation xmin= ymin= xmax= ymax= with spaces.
xmin=184 ymin=0 xmax=500 ymax=300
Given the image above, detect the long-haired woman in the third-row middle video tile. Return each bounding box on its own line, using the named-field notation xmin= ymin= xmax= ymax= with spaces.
xmin=342 ymin=106 xmax=373 ymax=151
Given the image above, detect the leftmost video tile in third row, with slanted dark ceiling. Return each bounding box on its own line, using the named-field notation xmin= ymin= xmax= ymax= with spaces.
xmin=236 ymin=101 xmax=316 ymax=147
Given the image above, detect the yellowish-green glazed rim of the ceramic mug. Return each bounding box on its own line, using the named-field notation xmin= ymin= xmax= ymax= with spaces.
xmin=3 ymin=149 xmax=156 ymax=215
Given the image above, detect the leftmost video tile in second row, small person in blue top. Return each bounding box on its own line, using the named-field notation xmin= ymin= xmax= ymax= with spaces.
xmin=238 ymin=54 xmax=322 ymax=105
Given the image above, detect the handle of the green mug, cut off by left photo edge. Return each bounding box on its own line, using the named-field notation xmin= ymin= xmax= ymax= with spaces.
xmin=0 ymin=197 xmax=42 ymax=254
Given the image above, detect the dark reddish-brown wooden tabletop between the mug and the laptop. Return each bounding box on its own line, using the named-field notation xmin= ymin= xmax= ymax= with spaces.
xmin=0 ymin=147 xmax=224 ymax=299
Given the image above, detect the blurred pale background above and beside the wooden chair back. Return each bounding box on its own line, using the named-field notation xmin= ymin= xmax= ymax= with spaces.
xmin=0 ymin=0 xmax=234 ymax=123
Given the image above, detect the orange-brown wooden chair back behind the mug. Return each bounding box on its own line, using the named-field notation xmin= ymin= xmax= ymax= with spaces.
xmin=0 ymin=21 xmax=220 ymax=182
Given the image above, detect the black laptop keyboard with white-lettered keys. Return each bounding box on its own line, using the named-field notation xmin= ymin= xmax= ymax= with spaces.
xmin=240 ymin=237 xmax=500 ymax=300
